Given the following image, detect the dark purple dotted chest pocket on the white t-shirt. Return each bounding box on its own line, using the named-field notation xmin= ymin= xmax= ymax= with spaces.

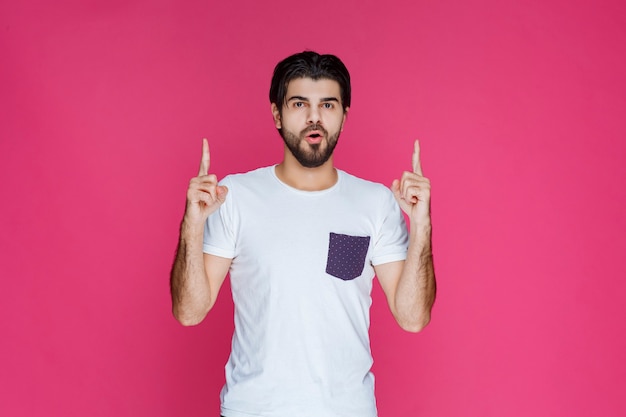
xmin=326 ymin=233 xmax=370 ymax=281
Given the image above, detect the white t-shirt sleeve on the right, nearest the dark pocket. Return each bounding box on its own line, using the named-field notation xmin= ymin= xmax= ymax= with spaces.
xmin=371 ymin=187 xmax=409 ymax=266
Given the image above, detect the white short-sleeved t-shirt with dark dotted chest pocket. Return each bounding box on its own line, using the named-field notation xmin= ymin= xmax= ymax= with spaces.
xmin=204 ymin=167 xmax=408 ymax=417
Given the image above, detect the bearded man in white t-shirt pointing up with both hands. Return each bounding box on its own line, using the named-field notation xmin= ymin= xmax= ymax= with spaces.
xmin=171 ymin=52 xmax=435 ymax=417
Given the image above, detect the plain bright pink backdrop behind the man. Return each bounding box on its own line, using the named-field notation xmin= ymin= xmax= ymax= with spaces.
xmin=0 ymin=0 xmax=626 ymax=417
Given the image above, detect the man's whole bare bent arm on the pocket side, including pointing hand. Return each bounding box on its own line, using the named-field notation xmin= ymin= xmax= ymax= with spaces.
xmin=374 ymin=141 xmax=437 ymax=332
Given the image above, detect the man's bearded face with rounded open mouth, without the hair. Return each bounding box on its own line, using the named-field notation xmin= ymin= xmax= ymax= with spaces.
xmin=272 ymin=78 xmax=348 ymax=168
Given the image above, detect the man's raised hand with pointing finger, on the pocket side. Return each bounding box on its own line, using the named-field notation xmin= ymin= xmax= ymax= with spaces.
xmin=391 ymin=140 xmax=430 ymax=221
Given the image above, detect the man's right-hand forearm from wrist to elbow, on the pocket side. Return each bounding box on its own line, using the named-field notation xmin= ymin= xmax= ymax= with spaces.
xmin=394 ymin=218 xmax=437 ymax=332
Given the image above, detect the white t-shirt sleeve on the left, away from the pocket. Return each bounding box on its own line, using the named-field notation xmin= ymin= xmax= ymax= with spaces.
xmin=202 ymin=177 xmax=236 ymax=259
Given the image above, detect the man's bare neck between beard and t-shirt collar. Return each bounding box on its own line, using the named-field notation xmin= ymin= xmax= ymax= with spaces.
xmin=276 ymin=149 xmax=338 ymax=191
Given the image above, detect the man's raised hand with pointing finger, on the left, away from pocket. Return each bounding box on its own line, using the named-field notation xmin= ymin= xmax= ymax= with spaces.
xmin=184 ymin=139 xmax=228 ymax=224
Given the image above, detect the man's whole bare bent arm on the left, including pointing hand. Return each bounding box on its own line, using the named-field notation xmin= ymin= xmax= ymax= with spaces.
xmin=170 ymin=139 xmax=232 ymax=326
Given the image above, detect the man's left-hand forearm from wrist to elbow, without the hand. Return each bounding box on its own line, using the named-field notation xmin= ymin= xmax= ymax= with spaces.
xmin=170 ymin=220 xmax=211 ymax=326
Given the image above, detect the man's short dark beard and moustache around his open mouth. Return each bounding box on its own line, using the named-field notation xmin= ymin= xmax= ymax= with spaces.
xmin=278 ymin=125 xmax=341 ymax=168
